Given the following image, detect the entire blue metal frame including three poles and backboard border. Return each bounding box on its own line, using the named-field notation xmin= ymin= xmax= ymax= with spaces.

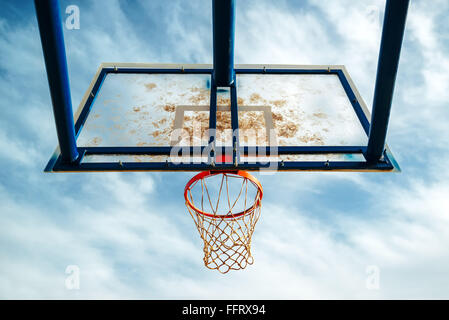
xmin=35 ymin=0 xmax=409 ymax=172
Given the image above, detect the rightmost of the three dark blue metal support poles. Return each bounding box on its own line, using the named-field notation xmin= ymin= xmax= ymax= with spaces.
xmin=365 ymin=0 xmax=409 ymax=162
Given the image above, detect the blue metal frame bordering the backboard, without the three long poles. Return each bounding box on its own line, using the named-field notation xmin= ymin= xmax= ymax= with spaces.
xmin=46 ymin=67 xmax=399 ymax=172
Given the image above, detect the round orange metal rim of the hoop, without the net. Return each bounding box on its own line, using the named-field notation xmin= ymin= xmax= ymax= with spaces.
xmin=184 ymin=170 xmax=263 ymax=219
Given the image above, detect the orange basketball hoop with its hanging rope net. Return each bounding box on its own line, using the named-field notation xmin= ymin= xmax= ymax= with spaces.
xmin=184 ymin=171 xmax=263 ymax=273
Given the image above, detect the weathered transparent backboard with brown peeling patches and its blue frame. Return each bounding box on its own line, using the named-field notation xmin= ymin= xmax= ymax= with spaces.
xmin=46 ymin=63 xmax=399 ymax=172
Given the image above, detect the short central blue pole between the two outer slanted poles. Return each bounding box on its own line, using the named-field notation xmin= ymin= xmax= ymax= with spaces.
xmin=212 ymin=0 xmax=235 ymax=87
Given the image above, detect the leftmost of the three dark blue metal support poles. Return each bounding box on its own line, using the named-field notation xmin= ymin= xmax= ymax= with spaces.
xmin=34 ymin=0 xmax=79 ymax=162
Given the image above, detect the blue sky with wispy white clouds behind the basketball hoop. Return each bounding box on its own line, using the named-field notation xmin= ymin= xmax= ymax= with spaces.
xmin=0 ymin=0 xmax=449 ymax=299
